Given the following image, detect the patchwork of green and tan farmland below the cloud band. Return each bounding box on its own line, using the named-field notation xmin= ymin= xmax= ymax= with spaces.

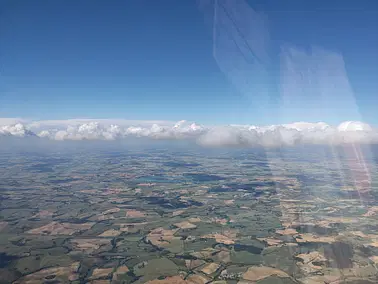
xmin=0 ymin=145 xmax=378 ymax=284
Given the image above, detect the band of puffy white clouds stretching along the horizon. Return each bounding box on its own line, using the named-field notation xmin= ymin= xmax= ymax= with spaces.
xmin=0 ymin=120 xmax=378 ymax=147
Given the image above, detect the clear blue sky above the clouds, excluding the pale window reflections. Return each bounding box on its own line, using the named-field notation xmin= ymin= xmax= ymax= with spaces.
xmin=0 ymin=0 xmax=378 ymax=125
